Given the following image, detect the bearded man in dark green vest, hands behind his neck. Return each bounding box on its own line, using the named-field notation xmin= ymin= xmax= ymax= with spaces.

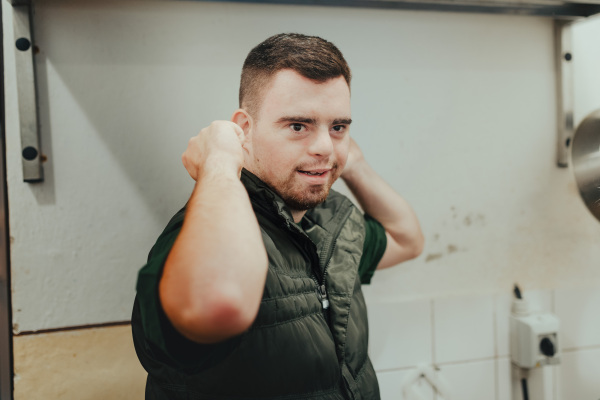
xmin=132 ymin=34 xmax=423 ymax=400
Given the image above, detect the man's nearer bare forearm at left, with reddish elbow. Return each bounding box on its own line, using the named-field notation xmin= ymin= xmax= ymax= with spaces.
xmin=159 ymin=166 xmax=267 ymax=343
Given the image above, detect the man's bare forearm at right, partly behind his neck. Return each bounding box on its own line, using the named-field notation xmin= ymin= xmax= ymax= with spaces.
xmin=342 ymin=159 xmax=424 ymax=267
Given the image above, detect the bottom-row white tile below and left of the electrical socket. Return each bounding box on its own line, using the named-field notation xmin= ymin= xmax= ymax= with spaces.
xmin=437 ymin=360 xmax=496 ymax=400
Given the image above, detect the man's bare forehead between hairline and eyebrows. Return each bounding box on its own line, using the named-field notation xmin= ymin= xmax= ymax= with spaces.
xmin=260 ymin=69 xmax=350 ymax=120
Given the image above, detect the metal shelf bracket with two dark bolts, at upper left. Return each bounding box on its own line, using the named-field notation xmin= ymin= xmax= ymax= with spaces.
xmin=12 ymin=1 xmax=44 ymax=182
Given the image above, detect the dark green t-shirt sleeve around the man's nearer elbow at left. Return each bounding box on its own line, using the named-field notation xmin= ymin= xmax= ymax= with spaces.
xmin=136 ymin=210 xmax=237 ymax=373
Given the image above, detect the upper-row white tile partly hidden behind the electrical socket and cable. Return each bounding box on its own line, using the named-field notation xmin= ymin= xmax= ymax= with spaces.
xmin=494 ymin=290 xmax=552 ymax=357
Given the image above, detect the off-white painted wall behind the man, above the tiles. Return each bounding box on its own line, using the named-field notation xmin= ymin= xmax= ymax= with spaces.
xmin=2 ymin=0 xmax=600 ymax=332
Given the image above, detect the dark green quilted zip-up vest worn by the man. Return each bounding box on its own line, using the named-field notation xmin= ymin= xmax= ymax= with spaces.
xmin=134 ymin=171 xmax=380 ymax=400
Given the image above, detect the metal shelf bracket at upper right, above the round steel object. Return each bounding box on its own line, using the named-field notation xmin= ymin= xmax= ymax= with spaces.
xmin=554 ymin=19 xmax=574 ymax=168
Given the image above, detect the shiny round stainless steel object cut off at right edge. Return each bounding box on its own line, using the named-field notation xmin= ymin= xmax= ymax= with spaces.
xmin=571 ymin=110 xmax=600 ymax=221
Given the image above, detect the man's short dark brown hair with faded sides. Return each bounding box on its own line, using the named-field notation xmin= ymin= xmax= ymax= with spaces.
xmin=239 ymin=33 xmax=352 ymax=115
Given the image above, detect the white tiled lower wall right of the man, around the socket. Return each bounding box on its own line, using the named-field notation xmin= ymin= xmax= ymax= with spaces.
xmin=367 ymin=288 xmax=600 ymax=400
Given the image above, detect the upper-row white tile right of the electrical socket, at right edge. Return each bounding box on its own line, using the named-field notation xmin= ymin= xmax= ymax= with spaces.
xmin=555 ymin=288 xmax=600 ymax=348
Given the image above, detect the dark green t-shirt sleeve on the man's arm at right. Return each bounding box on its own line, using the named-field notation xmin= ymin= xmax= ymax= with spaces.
xmin=358 ymin=214 xmax=387 ymax=284
